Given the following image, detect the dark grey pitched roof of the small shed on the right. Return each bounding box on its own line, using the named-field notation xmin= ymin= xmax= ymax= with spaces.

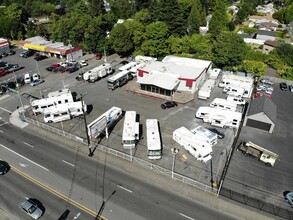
xmin=247 ymin=96 xmax=277 ymax=123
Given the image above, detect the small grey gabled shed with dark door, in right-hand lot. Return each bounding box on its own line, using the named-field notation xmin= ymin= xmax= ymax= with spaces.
xmin=243 ymin=96 xmax=277 ymax=133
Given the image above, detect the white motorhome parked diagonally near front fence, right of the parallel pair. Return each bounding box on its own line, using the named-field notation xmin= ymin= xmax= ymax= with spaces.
xmin=173 ymin=127 xmax=213 ymax=163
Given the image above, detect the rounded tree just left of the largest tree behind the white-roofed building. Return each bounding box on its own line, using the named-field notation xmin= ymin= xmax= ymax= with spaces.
xmin=110 ymin=24 xmax=134 ymax=55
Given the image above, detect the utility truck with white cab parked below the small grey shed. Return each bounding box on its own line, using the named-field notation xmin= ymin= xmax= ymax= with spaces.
xmin=237 ymin=141 xmax=279 ymax=167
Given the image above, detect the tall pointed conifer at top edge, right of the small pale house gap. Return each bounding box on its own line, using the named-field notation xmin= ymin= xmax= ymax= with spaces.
xmin=209 ymin=0 xmax=229 ymax=37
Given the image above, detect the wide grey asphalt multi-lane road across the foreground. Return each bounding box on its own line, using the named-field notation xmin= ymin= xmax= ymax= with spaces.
xmin=0 ymin=120 xmax=248 ymax=220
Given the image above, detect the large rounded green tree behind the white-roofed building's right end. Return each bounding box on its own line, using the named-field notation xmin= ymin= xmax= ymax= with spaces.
xmin=212 ymin=31 xmax=247 ymax=68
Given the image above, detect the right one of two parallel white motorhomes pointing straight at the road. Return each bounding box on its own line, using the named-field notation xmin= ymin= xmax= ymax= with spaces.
xmin=146 ymin=119 xmax=162 ymax=160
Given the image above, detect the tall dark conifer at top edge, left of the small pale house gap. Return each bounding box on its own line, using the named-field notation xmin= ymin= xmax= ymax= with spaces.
xmin=188 ymin=0 xmax=206 ymax=34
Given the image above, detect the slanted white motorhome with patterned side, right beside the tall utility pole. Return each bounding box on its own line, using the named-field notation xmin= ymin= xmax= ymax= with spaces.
xmin=87 ymin=106 xmax=122 ymax=138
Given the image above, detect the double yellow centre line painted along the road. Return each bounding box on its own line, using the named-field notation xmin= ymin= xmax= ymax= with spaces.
xmin=11 ymin=166 xmax=100 ymax=219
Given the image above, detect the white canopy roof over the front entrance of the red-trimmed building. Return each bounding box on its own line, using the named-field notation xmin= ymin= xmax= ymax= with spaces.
xmin=138 ymin=73 xmax=179 ymax=90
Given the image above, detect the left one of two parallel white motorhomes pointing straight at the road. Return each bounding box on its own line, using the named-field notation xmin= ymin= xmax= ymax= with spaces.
xmin=122 ymin=111 xmax=139 ymax=149
